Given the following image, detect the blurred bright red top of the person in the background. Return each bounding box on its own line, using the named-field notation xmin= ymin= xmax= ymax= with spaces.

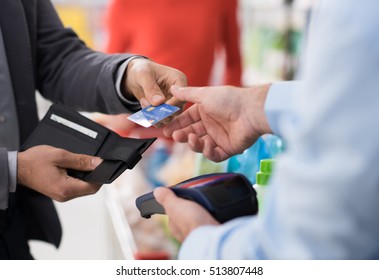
xmin=107 ymin=0 xmax=241 ymax=86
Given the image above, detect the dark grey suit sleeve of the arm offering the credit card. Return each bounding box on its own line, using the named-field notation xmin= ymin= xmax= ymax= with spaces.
xmin=36 ymin=0 xmax=138 ymax=114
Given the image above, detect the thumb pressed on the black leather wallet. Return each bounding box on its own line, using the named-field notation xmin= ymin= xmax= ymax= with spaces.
xmin=56 ymin=151 xmax=103 ymax=171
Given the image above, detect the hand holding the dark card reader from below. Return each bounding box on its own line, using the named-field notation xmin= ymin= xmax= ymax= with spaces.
xmin=154 ymin=188 xmax=219 ymax=242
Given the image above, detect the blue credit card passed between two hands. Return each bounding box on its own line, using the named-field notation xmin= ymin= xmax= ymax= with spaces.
xmin=128 ymin=103 xmax=180 ymax=127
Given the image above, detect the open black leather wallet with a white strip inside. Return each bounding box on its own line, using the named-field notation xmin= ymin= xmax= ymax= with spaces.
xmin=20 ymin=104 xmax=156 ymax=184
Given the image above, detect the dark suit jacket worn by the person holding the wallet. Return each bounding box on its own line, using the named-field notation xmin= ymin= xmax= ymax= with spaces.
xmin=0 ymin=0 xmax=137 ymax=258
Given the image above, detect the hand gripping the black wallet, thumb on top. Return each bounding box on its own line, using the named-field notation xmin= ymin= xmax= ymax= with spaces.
xmin=17 ymin=146 xmax=102 ymax=202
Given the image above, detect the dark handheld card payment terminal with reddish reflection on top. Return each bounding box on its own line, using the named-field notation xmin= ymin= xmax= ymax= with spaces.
xmin=136 ymin=173 xmax=258 ymax=223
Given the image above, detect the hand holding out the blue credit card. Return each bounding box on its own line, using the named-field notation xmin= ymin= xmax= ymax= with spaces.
xmin=123 ymin=58 xmax=187 ymax=107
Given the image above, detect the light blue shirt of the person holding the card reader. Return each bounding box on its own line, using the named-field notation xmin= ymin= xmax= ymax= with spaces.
xmin=179 ymin=0 xmax=379 ymax=259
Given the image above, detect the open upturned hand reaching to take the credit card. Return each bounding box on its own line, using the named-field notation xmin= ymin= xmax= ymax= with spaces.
xmin=163 ymin=85 xmax=271 ymax=162
